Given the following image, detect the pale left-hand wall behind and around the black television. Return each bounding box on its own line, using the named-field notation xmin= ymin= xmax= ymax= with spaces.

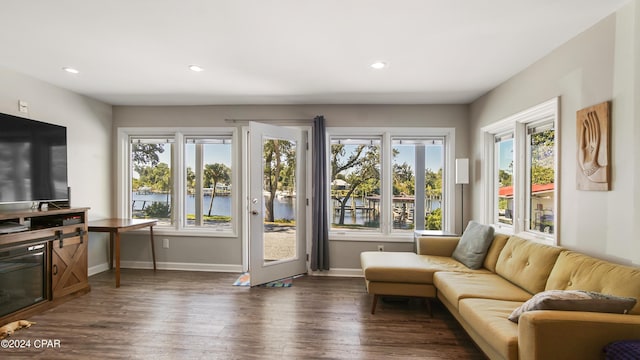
xmin=0 ymin=68 xmax=112 ymax=268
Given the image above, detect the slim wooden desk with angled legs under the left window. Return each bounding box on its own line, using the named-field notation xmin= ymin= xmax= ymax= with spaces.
xmin=89 ymin=219 xmax=158 ymax=288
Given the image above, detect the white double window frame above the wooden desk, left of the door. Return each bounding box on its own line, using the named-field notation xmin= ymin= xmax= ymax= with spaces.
xmin=116 ymin=127 xmax=241 ymax=237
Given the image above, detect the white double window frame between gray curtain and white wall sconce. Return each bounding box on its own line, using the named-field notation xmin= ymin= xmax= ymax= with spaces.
xmin=326 ymin=127 xmax=456 ymax=242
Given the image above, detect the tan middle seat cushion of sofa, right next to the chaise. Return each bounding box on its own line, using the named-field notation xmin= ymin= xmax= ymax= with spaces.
xmin=433 ymin=271 xmax=531 ymax=307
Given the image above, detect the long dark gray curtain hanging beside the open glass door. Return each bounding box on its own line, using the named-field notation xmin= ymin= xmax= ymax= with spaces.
xmin=311 ymin=116 xmax=329 ymax=271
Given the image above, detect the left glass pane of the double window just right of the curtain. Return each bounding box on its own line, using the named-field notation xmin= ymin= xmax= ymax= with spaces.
xmin=331 ymin=138 xmax=381 ymax=231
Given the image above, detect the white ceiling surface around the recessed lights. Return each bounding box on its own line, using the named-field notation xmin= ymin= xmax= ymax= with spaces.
xmin=0 ymin=0 xmax=628 ymax=105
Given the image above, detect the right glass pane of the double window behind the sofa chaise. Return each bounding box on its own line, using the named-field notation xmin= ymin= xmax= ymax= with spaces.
xmin=391 ymin=139 xmax=444 ymax=232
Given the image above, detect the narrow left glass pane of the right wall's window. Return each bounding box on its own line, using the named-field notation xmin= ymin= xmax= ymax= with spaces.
xmin=495 ymin=134 xmax=514 ymax=225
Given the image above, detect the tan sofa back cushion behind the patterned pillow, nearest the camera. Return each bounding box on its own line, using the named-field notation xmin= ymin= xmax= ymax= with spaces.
xmin=546 ymin=251 xmax=640 ymax=314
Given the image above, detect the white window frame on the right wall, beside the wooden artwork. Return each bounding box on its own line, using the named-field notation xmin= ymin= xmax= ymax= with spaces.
xmin=481 ymin=97 xmax=560 ymax=245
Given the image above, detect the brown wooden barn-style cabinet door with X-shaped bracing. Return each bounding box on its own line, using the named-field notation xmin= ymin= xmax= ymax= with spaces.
xmin=51 ymin=228 xmax=89 ymax=299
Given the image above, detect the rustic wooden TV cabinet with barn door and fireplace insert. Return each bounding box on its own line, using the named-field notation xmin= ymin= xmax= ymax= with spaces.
xmin=0 ymin=208 xmax=90 ymax=324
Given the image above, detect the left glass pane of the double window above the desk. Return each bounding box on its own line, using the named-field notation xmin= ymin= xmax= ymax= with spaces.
xmin=130 ymin=138 xmax=173 ymax=225
